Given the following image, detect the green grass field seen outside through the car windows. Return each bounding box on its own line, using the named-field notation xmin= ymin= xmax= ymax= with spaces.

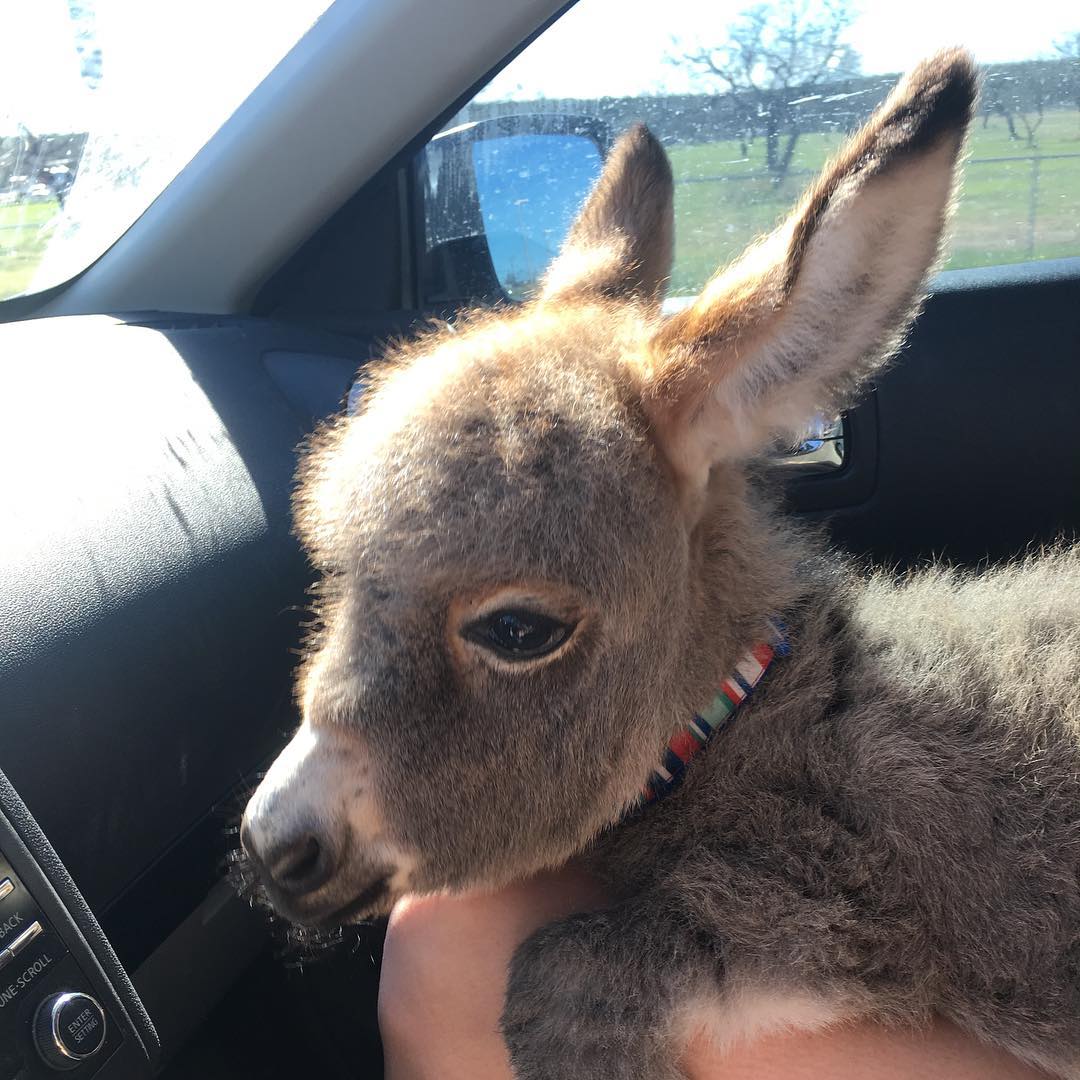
xmin=0 ymin=110 xmax=1080 ymax=299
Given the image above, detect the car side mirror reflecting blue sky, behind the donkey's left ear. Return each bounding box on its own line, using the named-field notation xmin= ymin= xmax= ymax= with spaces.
xmin=417 ymin=113 xmax=610 ymax=302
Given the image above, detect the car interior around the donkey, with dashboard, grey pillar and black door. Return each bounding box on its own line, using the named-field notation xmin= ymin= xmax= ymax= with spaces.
xmin=0 ymin=0 xmax=1080 ymax=1080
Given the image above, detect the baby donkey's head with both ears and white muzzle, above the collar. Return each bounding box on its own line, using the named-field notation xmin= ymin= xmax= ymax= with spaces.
xmin=242 ymin=52 xmax=976 ymax=923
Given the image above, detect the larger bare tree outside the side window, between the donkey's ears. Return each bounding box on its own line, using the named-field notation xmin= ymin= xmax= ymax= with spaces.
xmin=667 ymin=0 xmax=860 ymax=183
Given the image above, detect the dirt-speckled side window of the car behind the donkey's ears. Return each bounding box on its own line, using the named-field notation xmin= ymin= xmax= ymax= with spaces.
xmin=418 ymin=0 xmax=1080 ymax=300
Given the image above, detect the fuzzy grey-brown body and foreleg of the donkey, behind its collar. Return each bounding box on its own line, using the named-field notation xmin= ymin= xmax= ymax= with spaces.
xmin=524 ymin=551 xmax=1080 ymax=1078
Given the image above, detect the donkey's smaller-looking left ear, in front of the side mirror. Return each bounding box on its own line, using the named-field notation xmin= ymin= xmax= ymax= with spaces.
xmin=540 ymin=124 xmax=674 ymax=302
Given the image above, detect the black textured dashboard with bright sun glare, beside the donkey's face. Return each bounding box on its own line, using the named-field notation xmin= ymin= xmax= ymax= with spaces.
xmin=0 ymin=316 xmax=378 ymax=1078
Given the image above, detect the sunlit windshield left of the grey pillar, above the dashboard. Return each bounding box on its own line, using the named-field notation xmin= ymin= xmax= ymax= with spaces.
xmin=0 ymin=0 xmax=332 ymax=300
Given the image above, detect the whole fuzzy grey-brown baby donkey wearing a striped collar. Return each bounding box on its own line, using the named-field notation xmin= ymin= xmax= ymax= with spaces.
xmin=242 ymin=51 xmax=1080 ymax=1080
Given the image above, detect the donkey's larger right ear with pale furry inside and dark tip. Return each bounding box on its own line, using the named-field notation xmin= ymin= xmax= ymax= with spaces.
xmin=644 ymin=50 xmax=977 ymax=490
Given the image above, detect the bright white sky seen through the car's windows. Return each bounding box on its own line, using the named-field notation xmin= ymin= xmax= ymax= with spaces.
xmin=0 ymin=0 xmax=1080 ymax=138
